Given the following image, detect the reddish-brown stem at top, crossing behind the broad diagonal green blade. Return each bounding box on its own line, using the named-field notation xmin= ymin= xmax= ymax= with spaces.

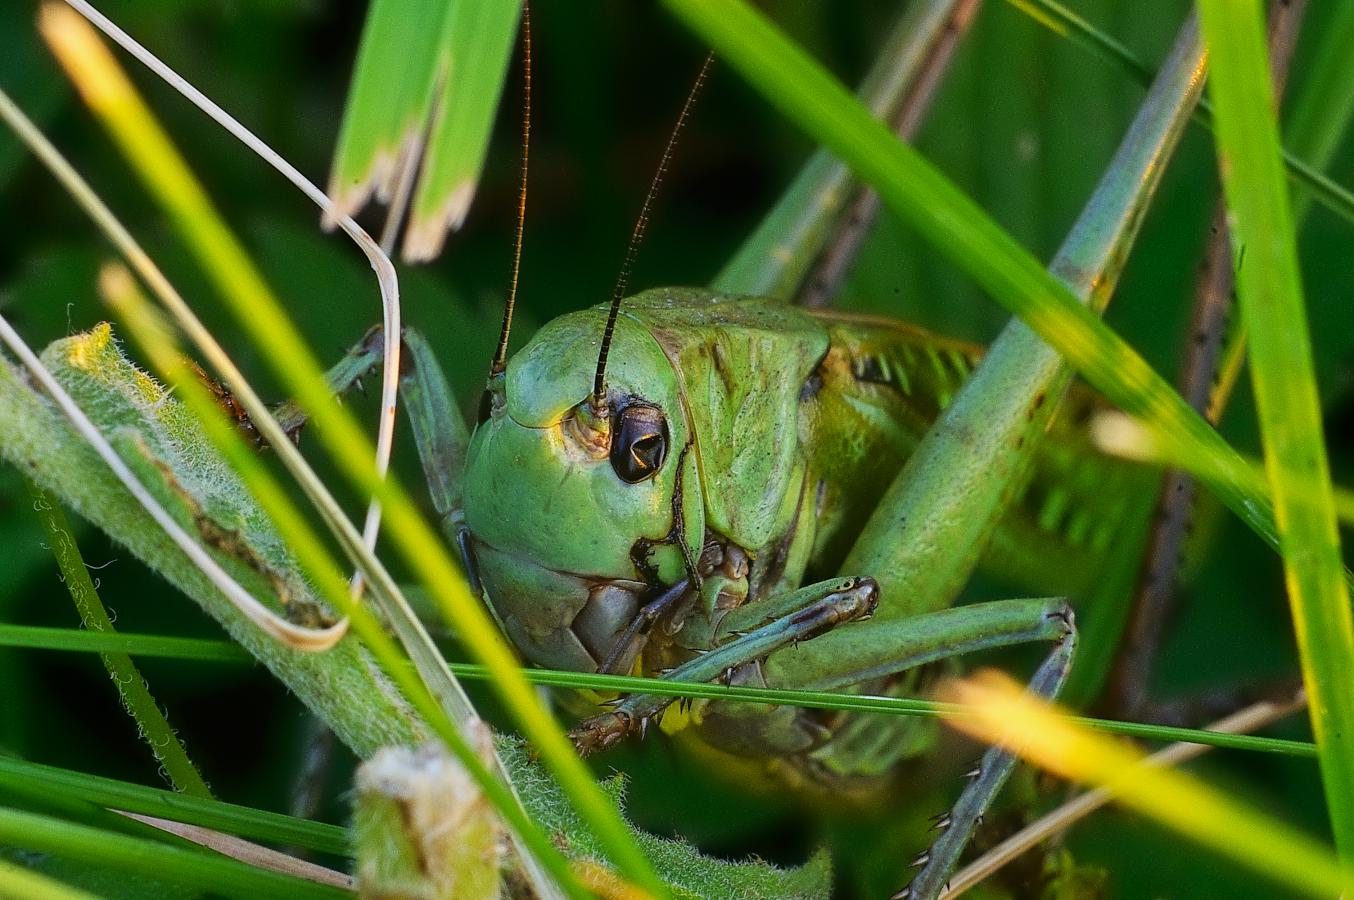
xmin=795 ymin=0 xmax=982 ymax=310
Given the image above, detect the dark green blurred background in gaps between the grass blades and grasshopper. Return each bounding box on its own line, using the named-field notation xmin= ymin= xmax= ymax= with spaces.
xmin=0 ymin=0 xmax=1354 ymax=897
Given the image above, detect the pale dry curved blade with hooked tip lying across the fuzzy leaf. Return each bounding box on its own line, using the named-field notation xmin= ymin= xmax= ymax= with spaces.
xmin=0 ymin=315 xmax=348 ymax=651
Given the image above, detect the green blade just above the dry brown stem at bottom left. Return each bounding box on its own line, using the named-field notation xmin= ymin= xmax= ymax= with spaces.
xmin=0 ymin=757 xmax=351 ymax=857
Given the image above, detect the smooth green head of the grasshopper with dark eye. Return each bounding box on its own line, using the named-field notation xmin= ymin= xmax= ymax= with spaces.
xmin=464 ymin=310 xmax=704 ymax=671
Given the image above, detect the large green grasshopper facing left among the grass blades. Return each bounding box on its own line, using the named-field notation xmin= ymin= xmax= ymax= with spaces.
xmin=285 ymin=7 xmax=1197 ymax=897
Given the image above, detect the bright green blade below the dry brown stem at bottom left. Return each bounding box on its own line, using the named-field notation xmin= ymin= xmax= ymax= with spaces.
xmin=0 ymin=808 xmax=352 ymax=900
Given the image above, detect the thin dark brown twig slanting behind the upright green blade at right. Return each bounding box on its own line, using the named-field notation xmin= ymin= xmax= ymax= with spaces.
xmin=1102 ymin=0 xmax=1307 ymax=719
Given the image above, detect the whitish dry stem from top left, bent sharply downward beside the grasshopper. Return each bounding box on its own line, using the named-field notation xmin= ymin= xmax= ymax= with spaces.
xmin=59 ymin=0 xmax=401 ymax=625
